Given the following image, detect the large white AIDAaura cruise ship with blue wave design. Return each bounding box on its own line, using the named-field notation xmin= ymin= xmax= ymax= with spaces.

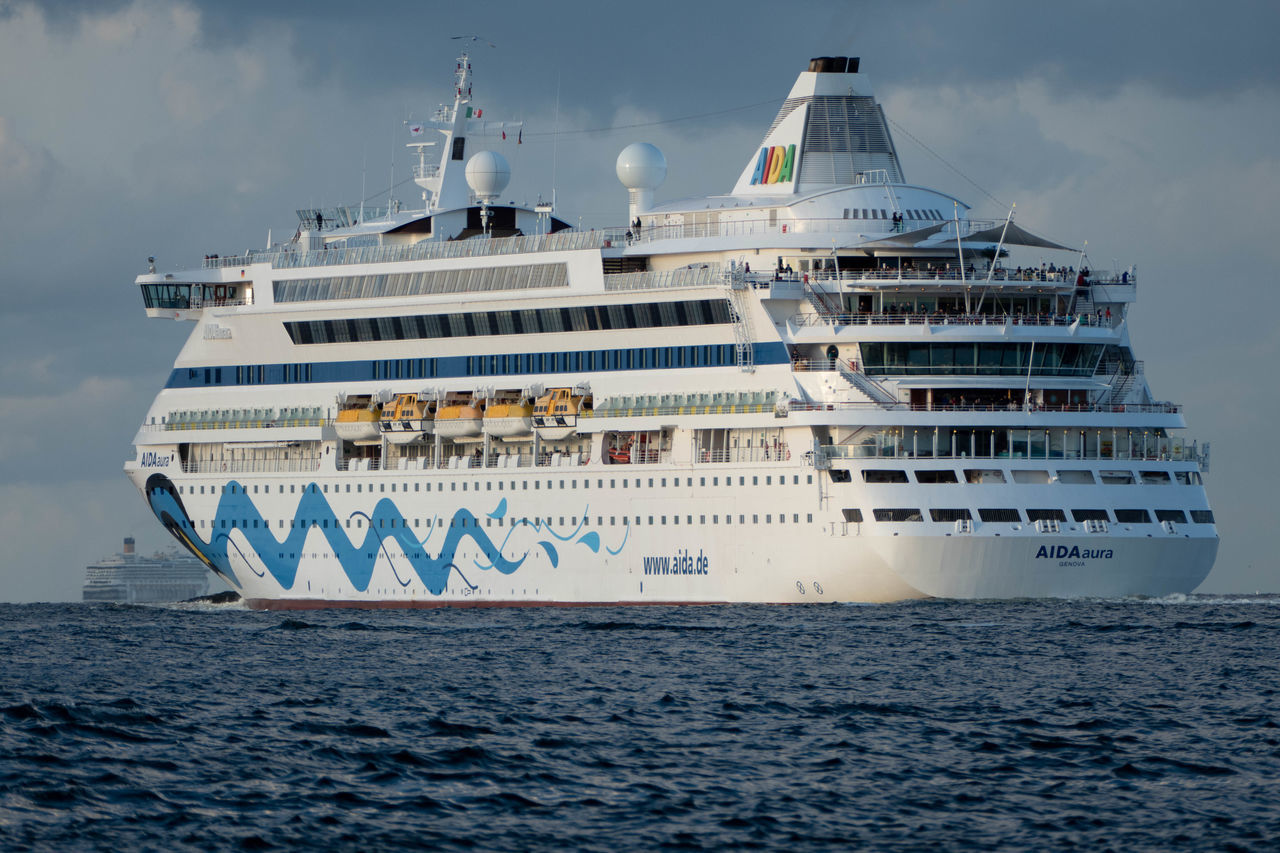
xmin=125 ymin=55 xmax=1219 ymax=608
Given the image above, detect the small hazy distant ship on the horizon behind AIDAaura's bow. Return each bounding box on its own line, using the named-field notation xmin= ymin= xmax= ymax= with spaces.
xmin=82 ymin=537 xmax=221 ymax=605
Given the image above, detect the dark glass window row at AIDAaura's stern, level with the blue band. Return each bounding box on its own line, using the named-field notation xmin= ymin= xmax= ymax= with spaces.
xmin=861 ymin=342 xmax=1106 ymax=377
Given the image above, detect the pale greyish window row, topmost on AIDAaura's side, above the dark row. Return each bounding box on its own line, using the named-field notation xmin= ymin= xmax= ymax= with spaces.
xmin=271 ymin=264 xmax=568 ymax=302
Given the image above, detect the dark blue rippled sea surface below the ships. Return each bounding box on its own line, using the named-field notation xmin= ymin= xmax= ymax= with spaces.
xmin=0 ymin=596 xmax=1280 ymax=852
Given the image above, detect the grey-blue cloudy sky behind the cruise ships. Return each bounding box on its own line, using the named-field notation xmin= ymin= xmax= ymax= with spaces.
xmin=0 ymin=0 xmax=1280 ymax=601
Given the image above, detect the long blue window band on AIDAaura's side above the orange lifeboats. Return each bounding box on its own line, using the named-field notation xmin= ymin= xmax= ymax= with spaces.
xmin=165 ymin=342 xmax=787 ymax=388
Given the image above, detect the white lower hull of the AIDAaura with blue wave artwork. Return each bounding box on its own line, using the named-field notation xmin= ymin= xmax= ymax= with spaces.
xmin=124 ymin=455 xmax=1217 ymax=608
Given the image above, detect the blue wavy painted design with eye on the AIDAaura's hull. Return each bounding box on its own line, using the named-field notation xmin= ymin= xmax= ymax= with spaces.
xmin=146 ymin=474 xmax=630 ymax=596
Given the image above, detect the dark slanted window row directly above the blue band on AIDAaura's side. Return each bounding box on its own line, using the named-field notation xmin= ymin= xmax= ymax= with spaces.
xmin=284 ymin=300 xmax=732 ymax=343
